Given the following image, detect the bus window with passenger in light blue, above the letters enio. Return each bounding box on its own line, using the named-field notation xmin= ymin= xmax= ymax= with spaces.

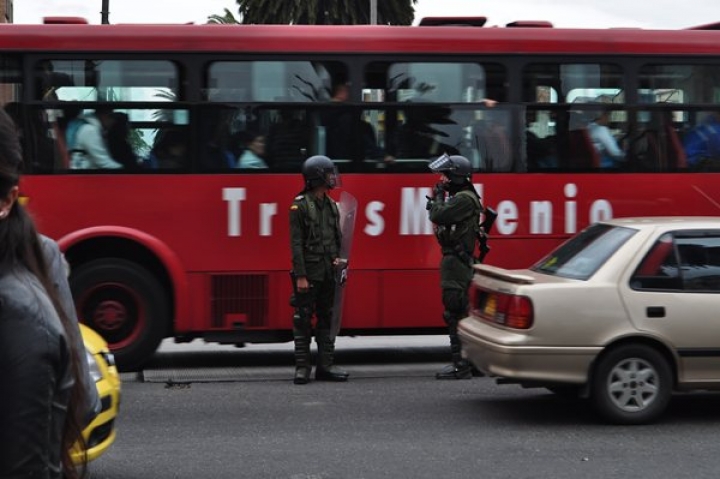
xmin=522 ymin=63 xmax=628 ymax=170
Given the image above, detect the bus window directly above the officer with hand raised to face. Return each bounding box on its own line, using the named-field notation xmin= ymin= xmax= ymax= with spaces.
xmin=363 ymin=62 xmax=518 ymax=171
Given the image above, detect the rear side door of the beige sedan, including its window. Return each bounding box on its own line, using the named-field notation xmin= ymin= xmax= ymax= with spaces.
xmin=621 ymin=230 xmax=720 ymax=385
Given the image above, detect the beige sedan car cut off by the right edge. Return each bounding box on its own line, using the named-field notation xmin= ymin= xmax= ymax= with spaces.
xmin=458 ymin=217 xmax=720 ymax=424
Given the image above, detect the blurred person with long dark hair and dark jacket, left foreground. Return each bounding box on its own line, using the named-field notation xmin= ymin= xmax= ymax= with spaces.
xmin=0 ymin=112 xmax=85 ymax=479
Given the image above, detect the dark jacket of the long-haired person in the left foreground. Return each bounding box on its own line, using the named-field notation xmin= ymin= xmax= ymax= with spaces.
xmin=0 ymin=267 xmax=73 ymax=479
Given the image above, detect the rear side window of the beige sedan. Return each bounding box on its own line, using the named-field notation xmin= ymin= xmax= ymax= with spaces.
xmin=630 ymin=231 xmax=720 ymax=292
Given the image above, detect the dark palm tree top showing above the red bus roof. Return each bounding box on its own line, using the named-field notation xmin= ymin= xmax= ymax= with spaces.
xmin=208 ymin=0 xmax=417 ymax=25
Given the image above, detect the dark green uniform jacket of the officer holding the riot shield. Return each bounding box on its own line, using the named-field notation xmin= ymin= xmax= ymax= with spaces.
xmin=290 ymin=193 xmax=340 ymax=281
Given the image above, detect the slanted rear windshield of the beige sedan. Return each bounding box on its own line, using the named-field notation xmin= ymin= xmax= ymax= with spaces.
xmin=530 ymin=224 xmax=637 ymax=280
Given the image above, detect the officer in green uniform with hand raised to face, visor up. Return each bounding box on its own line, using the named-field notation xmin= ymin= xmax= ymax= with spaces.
xmin=427 ymin=155 xmax=483 ymax=379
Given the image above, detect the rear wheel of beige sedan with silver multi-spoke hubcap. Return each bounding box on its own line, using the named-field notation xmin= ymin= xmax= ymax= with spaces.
xmin=591 ymin=344 xmax=673 ymax=424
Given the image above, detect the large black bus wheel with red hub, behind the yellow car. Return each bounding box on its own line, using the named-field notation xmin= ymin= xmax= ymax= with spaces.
xmin=70 ymin=259 xmax=169 ymax=371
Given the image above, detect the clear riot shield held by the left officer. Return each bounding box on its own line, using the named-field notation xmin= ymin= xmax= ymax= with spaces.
xmin=330 ymin=191 xmax=357 ymax=339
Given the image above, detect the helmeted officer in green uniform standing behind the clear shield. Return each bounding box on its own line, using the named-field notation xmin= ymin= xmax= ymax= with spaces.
xmin=290 ymin=155 xmax=348 ymax=384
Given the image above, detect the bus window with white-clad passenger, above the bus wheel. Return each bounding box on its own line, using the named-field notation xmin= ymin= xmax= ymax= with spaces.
xmin=33 ymin=59 xmax=181 ymax=172
